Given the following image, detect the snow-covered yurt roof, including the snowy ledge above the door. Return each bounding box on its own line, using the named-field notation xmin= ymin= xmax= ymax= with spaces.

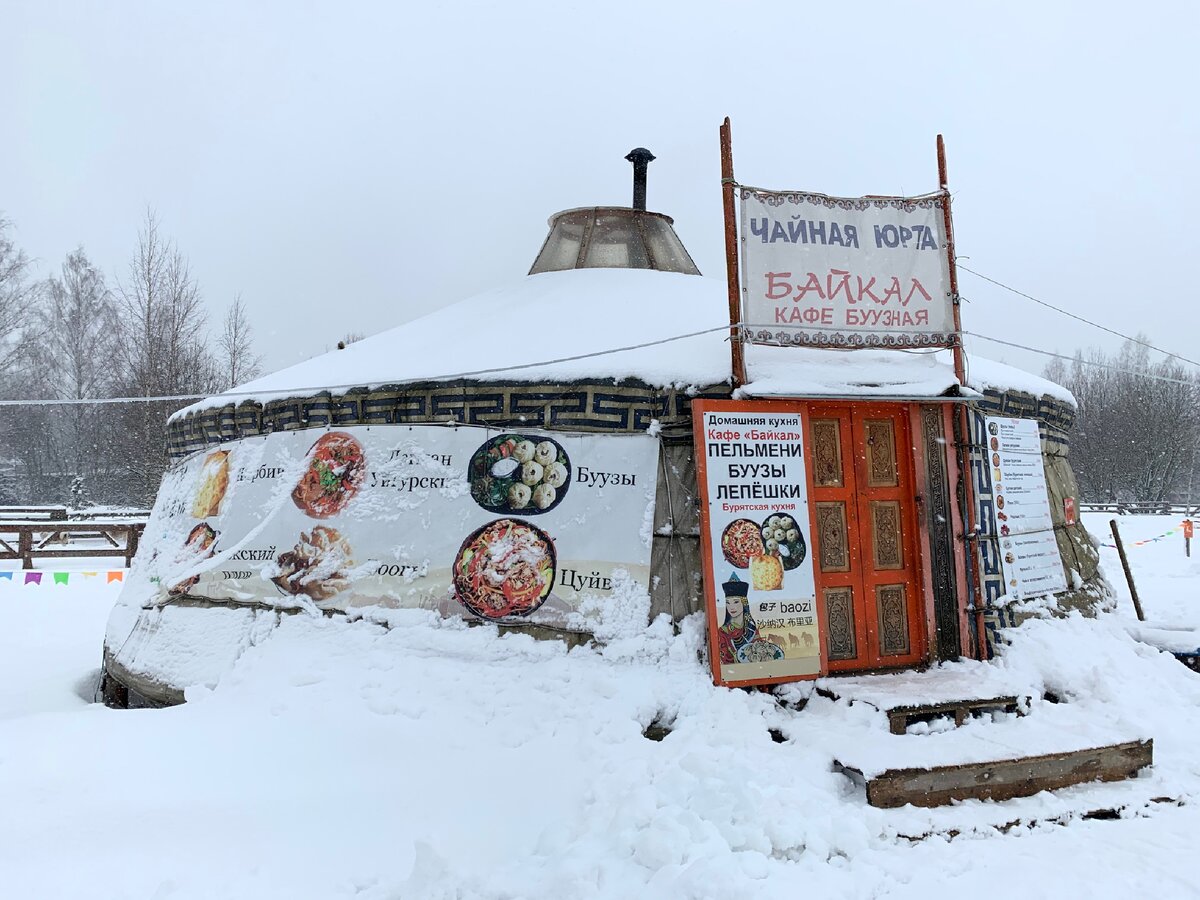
xmin=173 ymin=269 xmax=1073 ymax=421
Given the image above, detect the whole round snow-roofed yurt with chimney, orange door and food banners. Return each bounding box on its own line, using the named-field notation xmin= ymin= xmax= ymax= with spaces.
xmin=103 ymin=151 xmax=1108 ymax=707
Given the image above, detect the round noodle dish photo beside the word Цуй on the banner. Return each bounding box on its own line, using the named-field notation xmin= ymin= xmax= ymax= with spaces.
xmin=454 ymin=518 xmax=557 ymax=619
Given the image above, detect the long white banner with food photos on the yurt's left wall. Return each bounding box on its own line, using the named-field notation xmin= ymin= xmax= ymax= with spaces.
xmin=134 ymin=425 xmax=658 ymax=628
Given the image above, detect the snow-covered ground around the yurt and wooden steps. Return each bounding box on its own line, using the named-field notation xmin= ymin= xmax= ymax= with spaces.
xmin=0 ymin=516 xmax=1200 ymax=900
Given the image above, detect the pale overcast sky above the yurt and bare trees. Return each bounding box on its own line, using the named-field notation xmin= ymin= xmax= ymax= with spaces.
xmin=0 ymin=0 xmax=1200 ymax=381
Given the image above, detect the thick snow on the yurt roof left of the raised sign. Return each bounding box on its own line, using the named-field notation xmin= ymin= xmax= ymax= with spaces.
xmin=175 ymin=269 xmax=730 ymax=416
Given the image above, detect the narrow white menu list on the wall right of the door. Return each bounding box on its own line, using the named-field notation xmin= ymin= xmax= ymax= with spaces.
xmin=986 ymin=416 xmax=1067 ymax=600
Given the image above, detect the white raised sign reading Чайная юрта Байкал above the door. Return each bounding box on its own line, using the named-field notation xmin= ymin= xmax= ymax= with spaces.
xmin=740 ymin=187 xmax=954 ymax=347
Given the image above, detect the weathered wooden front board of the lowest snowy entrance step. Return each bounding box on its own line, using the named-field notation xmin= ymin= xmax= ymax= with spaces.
xmin=866 ymin=740 xmax=1154 ymax=809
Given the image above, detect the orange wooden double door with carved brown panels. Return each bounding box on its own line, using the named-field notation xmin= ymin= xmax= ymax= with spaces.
xmin=809 ymin=403 xmax=926 ymax=672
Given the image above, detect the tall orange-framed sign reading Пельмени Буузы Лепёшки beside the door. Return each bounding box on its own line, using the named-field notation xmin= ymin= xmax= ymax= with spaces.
xmin=692 ymin=401 xmax=822 ymax=684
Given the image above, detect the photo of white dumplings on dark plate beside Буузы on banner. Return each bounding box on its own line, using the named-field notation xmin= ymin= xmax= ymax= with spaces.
xmin=467 ymin=433 xmax=571 ymax=516
